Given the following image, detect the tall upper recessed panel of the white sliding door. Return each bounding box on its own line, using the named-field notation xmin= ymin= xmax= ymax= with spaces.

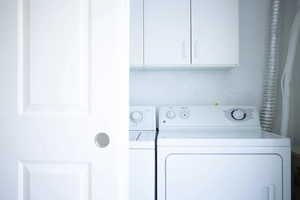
xmin=17 ymin=0 xmax=90 ymax=114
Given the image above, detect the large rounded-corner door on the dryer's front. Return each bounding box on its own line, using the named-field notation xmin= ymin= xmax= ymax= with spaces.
xmin=165 ymin=154 xmax=282 ymax=200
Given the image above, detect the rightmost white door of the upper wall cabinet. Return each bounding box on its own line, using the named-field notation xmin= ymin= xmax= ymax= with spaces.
xmin=191 ymin=0 xmax=239 ymax=66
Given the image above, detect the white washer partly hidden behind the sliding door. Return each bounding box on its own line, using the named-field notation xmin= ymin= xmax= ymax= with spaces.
xmin=129 ymin=106 xmax=156 ymax=200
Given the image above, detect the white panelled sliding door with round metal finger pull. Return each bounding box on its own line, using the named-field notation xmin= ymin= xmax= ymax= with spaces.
xmin=0 ymin=0 xmax=129 ymax=200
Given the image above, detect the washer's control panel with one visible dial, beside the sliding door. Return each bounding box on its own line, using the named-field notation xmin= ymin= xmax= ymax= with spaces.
xmin=129 ymin=106 xmax=156 ymax=131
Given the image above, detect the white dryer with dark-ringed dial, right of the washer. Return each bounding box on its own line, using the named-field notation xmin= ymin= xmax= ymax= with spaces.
xmin=157 ymin=106 xmax=291 ymax=200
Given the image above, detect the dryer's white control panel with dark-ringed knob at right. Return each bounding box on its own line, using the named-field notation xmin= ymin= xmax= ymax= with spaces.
xmin=159 ymin=105 xmax=260 ymax=130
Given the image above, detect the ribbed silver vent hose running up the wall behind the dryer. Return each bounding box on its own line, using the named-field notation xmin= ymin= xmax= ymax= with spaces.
xmin=260 ymin=0 xmax=280 ymax=132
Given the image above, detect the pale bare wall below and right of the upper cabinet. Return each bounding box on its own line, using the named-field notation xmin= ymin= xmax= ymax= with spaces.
xmin=130 ymin=0 xmax=271 ymax=106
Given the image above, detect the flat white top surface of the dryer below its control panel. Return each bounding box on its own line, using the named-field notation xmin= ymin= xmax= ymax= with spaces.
xmin=157 ymin=130 xmax=290 ymax=147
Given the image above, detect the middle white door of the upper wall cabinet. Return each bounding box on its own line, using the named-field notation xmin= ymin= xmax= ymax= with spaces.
xmin=144 ymin=0 xmax=190 ymax=65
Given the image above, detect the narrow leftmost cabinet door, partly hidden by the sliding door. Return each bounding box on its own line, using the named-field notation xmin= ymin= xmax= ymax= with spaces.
xmin=130 ymin=0 xmax=144 ymax=65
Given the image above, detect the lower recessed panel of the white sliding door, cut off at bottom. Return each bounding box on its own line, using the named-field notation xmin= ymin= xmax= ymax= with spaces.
xmin=18 ymin=161 xmax=91 ymax=200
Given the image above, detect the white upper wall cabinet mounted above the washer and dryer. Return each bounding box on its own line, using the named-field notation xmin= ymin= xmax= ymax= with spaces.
xmin=131 ymin=0 xmax=239 ymax=67
